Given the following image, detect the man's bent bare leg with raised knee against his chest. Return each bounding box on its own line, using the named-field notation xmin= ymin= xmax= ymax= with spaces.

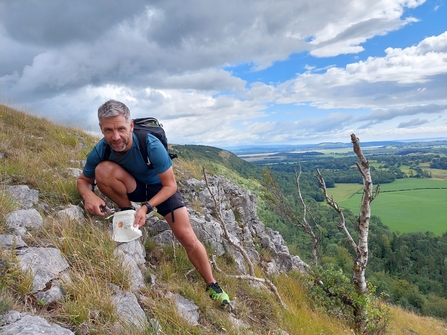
xmin=95 ymin=161 xmax=137 ymax=208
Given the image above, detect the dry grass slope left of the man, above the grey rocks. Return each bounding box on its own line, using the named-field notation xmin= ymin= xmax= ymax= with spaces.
xmin=0 ymin=105 xmax=96 ymax=205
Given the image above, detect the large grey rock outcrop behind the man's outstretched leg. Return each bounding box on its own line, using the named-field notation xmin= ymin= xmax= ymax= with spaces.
xmin=175 ymin=176 xmax=307 ymax=274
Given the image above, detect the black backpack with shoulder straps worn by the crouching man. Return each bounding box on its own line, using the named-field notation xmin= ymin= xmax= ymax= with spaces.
xmin=104 ymin=117 xmax=177 ymax=169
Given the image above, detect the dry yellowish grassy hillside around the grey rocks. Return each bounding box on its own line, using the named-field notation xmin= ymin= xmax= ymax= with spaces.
xmin=0 ymin=105 xmax=447 ymax=335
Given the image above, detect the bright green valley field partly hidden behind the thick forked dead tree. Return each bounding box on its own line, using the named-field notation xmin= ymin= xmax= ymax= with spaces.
xmin=338 ymin=178 xmax=447 ymax=235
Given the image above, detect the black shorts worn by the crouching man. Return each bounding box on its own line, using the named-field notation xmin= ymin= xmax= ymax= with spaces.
xmin=127 ymin=181 xmax=185 ymax=216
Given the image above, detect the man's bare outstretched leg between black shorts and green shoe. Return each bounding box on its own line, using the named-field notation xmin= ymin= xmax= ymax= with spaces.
xmin=165 ymin=207 xmax=216 ymax=285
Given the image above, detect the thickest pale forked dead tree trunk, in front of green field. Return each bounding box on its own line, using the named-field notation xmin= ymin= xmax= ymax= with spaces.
xmin=317 ymin=134 xmax=380 ymax=294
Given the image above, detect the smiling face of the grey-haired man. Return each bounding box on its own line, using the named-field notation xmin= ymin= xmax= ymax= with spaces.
xmin=99 ymin=115 xmax=133 ymax=152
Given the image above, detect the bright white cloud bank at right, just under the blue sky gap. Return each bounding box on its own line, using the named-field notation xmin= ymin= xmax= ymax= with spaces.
xmin=277 ymin=32 xmax=447 ymax=108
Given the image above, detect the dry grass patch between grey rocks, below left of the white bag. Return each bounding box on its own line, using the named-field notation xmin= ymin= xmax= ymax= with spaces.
xmin=41 ymin=217 xmax=130 ymax=333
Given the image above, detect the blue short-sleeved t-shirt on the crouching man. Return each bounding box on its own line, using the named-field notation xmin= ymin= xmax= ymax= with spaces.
xmin=83 ymin=133 xmax=172 ymax=184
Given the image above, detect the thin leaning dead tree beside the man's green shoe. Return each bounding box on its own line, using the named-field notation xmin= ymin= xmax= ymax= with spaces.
xmin=202 ymin=167 xmax=288 ymax=308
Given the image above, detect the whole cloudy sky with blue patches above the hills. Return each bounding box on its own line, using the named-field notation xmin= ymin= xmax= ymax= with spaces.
xmin=0 ymin=0 xmax=447 ymax=148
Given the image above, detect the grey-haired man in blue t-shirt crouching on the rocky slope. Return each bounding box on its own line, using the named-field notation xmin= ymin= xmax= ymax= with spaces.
xmin=77 ymin=100 xmax=230 ymax=304
